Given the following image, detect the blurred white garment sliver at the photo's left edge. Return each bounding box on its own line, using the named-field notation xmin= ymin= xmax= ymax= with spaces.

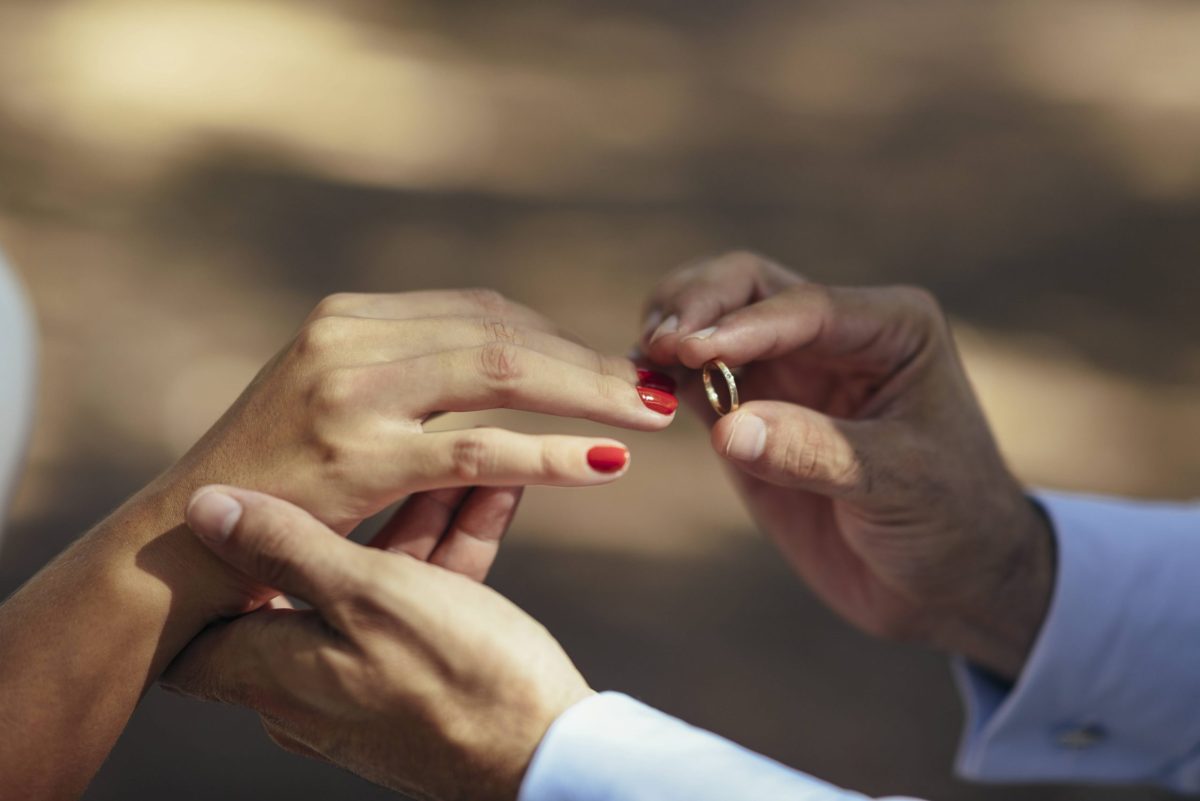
xmin=0 ymin=252 xmax=36 ymax=544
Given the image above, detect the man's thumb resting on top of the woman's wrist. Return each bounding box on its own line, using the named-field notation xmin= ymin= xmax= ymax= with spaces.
xmin=187 ymin=487 xmax=359 ymax=608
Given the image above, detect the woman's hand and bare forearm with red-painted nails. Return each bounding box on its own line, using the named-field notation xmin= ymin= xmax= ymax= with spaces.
xmin=0 ymin=286 xmax=676 ymax=799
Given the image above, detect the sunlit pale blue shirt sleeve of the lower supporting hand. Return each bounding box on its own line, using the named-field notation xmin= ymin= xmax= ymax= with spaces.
xmin=518 ymin=693 xmax=921 ymax=801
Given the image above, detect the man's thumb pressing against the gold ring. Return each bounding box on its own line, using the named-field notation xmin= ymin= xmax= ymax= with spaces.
xmin=712 ymin=401 xmax=877 ymax=496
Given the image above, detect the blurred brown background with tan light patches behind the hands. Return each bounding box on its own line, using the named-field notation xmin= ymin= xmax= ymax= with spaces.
xmin=0 ymin=0 xmax=1200 ymax=801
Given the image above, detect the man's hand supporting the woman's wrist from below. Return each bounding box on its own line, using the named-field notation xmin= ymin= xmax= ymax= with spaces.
xmin=164 ymin=487 xmax=592 ymax=801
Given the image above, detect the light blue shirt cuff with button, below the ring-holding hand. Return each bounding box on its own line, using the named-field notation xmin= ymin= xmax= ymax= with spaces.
xmin=955 ymin=494 xmax=1200 ymax=791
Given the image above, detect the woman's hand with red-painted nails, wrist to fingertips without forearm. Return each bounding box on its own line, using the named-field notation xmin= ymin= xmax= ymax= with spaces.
xmin=139 ymin=290 xmax=676 ymax=613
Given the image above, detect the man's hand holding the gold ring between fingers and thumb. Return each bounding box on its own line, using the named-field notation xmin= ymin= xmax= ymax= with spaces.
xmin=642 ymin=253 xmax=1054 ymax=677
